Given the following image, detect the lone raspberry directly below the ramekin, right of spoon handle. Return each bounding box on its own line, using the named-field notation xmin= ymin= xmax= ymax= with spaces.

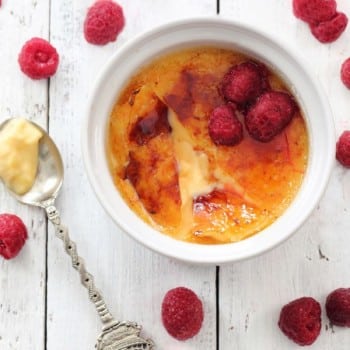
xmin=162 ymin=287 xmax=203 ymax=340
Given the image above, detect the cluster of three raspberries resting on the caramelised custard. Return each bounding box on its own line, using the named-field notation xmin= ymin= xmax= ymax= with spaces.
xmin=208 ymin=61 xmax=297 ymax=146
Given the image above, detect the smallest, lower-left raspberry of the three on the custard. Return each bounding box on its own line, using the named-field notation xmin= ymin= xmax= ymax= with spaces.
xmin=208 ymin=105 xmax=243 ymax=146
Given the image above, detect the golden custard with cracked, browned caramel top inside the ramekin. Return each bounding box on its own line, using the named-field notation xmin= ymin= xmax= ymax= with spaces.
xmin=107 ymin=47 xmax=308 ymax=244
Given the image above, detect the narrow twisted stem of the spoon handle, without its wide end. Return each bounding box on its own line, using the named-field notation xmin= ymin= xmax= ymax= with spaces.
xmin=43 ymin=202 xmax=114 ymax=324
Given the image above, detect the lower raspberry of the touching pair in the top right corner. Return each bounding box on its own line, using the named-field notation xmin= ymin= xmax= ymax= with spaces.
xmin=310 ymin=12 xmax=348 ymax=43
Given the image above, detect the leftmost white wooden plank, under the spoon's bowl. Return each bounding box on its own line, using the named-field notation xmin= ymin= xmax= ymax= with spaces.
xmin=0 ymin=0 xmax=49 ymax=350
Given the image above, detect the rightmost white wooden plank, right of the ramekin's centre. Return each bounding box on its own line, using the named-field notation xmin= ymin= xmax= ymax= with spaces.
xmin=220 ymin=0 xmax=350 ymax=350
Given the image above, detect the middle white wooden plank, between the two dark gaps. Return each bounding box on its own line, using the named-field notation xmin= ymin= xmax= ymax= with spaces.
xmin=47 ymin=0 xmax=216 ymax=350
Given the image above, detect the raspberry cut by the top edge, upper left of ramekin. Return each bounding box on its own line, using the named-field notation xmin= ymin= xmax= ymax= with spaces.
xmin=84 ymin=0 xmax=125 ymax=45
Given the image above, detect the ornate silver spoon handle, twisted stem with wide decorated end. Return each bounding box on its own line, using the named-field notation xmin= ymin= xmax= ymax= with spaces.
xmin=41 ymin=199 xmax=154 ymax=350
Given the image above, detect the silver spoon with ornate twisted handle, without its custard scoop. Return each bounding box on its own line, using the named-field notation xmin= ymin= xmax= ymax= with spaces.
xmin=0 ymin=119 xmax=154 ymax=350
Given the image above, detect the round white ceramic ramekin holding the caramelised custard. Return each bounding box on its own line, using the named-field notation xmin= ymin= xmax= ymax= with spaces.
xmin=82 ymin=18 xmax=335 ymax=264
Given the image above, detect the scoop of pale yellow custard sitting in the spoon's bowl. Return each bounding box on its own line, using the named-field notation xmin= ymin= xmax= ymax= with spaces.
xmin=0 ymin=118 xmax=43 ymax=195
